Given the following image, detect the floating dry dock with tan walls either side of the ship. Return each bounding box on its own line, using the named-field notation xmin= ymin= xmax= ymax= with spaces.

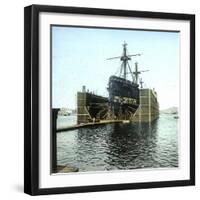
xmin=77 ymin=88 xmax=159 ymax=125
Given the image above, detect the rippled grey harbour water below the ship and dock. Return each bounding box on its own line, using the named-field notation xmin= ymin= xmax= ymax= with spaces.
xmin=57 ymin=114 xmax=178 ymax=172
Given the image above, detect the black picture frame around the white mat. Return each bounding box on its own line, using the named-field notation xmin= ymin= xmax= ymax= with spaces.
xmin=24 ymin=5 xmax=195 ymax=195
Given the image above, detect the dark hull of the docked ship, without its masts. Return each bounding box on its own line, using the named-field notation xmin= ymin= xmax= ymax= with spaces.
xmin=108 ymin=76 xmax=140 ymax=120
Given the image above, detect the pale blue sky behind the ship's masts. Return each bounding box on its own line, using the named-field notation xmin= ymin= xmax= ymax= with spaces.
xmin=51 ymin=26 xmax=180 ymax=109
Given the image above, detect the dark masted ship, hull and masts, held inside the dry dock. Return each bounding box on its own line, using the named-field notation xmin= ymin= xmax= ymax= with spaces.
xmin=107 ymin=42 xmax=147 ymax=120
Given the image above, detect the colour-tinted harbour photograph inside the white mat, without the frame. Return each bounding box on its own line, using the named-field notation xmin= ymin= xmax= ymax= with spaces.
xmin=50 ymin=24 xmax=181 ymax=174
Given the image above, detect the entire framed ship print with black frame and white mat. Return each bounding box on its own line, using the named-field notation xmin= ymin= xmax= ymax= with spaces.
xmin=24 ymin=5 xmax=195 ymax=195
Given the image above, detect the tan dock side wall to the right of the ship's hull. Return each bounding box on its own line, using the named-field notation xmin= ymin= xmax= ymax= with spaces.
xmin=132 ymin=89 xmax=159 ymax=122
